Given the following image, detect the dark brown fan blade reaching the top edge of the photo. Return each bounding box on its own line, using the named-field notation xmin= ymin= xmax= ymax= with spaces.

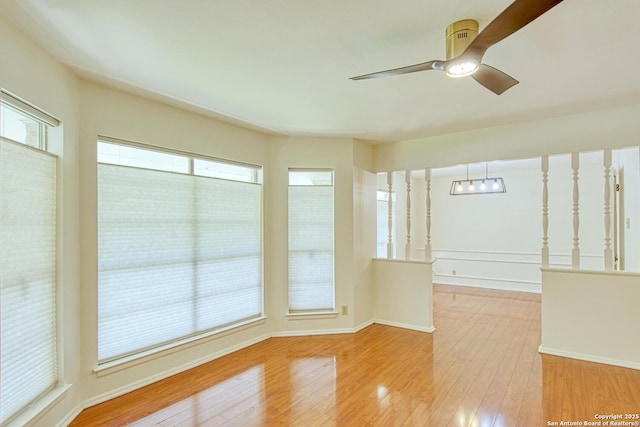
xmin=460 ymin=0 xmax=563 ymax=62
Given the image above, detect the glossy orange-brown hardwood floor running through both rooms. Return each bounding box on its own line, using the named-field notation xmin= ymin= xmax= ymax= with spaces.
xmin=71 ymin=285 xmax=640 ymax=427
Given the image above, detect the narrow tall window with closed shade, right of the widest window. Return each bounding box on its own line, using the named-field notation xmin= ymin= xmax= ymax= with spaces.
xmin=289 ymin=169 xmax=335 ymax=312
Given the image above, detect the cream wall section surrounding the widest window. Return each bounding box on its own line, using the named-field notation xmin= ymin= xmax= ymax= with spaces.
xmin=78 ymin=81 xmax=270 ymax=405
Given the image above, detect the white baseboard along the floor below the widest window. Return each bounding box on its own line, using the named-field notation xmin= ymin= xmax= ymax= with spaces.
xmin=83 ymin=334 xmax=271 ymax=408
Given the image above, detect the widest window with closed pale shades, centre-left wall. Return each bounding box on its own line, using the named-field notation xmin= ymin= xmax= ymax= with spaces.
xmin=98 ymin=140 xmax=262 ymax=363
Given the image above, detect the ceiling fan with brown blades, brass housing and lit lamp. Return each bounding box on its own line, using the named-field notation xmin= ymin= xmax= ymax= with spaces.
xmin=351 ymin=0 xmax=563 ymax=95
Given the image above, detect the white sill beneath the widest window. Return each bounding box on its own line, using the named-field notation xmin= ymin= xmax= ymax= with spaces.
xmin=93 ymin=316 xmax=267 ymax=378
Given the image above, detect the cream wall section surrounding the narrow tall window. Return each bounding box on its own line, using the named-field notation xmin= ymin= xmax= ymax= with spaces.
xmin=265 ymin=136 xmax=355 ymax=336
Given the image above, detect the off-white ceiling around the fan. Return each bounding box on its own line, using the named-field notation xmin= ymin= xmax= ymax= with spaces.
xmin=0 ymin=0 xmax=640 ymax=141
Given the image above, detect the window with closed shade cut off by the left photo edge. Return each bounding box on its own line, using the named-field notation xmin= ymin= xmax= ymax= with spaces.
xmin=0 ymin=91 xmax=59 ymax=424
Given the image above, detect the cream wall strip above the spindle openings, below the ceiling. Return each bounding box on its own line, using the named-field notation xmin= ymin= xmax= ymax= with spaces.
xmin=374 ymin=104 xmax=640 ymax=172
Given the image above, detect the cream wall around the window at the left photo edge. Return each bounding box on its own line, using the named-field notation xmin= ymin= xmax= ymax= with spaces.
xmin=0 ymin=16 xmax=82 ymax=427
